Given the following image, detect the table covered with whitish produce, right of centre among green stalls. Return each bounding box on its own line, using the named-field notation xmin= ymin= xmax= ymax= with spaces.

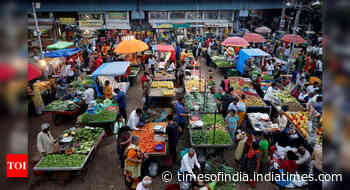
xmin=247 ymin=113 xmax=278 ymax=133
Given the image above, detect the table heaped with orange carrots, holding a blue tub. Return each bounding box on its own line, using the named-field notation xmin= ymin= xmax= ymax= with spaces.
xmin=132 ymin=122 xmax=167 ymax=156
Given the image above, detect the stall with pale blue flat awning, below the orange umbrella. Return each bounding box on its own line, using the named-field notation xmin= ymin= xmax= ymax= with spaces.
xmin=92 ymin=61 xmax=130 ymax=97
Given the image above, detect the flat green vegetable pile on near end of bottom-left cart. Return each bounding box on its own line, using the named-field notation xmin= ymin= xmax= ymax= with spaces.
xmin=37 ymin=154 xmax=86 ymax=168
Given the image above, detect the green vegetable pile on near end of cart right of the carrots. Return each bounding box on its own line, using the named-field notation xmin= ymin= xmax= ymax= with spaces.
xmin=192 ymin=129 xmax=232 ymax=145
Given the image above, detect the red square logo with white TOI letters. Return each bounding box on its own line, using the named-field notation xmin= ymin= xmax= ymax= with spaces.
xmin=6 ymin=154 xmax=28 ymax=178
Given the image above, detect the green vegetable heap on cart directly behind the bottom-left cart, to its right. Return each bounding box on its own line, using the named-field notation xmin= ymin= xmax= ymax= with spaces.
xmin=80 ymin=110 xmax=116 ymax=123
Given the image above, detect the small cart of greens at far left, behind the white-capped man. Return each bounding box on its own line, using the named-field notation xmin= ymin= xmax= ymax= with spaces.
xmin=43 ymin=100 xmax=85 ymax=124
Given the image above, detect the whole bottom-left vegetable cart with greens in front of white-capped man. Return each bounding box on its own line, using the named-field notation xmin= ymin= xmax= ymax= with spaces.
xmin=33 ymin=127 xmax=105 ymax=180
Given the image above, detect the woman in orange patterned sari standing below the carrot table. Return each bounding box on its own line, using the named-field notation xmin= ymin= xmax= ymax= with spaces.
xmin=124 ymin=136 xmax=143 ymax=189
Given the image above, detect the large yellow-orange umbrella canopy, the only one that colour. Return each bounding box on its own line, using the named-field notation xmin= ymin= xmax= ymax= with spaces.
xmin=114 ymin=40 xmax=148 ymax=54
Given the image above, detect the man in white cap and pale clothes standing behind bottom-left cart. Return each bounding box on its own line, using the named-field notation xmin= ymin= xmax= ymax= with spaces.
xmin=37 ymin=123 xmax=56 ymax=157
